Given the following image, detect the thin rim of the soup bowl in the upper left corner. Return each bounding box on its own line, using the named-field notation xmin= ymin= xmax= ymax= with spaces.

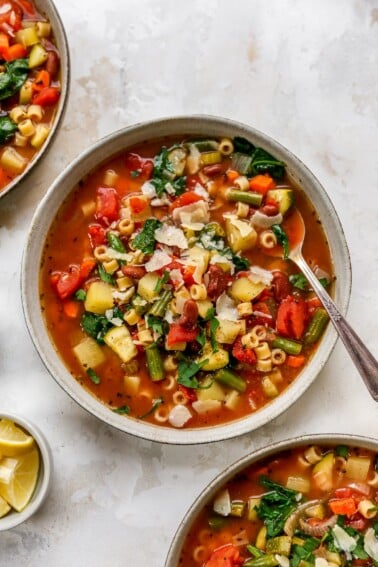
xmin=0 ymin=0 xmax=70 ymax=199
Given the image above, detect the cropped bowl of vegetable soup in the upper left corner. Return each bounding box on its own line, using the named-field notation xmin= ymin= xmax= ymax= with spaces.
xmin=0 ymin=0 xmax=69 ymax=198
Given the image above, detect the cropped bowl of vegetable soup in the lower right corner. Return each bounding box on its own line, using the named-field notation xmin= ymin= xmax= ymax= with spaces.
xmin=165 ymin=434 xmax=378 ymax=567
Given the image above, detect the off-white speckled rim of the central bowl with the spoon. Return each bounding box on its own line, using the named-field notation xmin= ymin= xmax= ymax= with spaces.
xmin=21 ymin=115 xmax=351 ymax=445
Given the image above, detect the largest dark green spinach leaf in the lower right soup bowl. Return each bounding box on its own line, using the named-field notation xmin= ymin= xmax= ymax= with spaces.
xmin=256 ymin=475 xmax=299 ymax=537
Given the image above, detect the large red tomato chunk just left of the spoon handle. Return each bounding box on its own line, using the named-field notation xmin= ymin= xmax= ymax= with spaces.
xmin=276 ymin=296 xmax=307 ymax=339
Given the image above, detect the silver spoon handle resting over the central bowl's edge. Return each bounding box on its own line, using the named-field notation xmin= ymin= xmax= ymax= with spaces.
xmin=292 ymin=254 xmax=378 ymax=402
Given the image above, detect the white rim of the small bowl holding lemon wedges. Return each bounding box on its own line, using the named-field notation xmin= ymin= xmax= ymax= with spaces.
xmin=0 ymin=410 xmax=53 ymax=532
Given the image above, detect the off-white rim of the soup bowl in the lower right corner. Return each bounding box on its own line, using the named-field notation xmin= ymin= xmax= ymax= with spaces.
xmin=164 ymin=433 xmax=378 ymax=567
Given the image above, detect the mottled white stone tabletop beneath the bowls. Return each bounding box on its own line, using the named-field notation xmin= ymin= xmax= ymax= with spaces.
xmin=0 ymin=0 xmax=378 ymax=567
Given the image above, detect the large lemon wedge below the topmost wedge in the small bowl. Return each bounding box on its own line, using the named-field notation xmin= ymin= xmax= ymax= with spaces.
xmin=0 ymin=448 xmax=39 ymax=512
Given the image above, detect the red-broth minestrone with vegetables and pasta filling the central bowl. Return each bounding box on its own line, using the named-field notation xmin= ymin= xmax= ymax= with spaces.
xmin=41 ymin=138 xmax=332 ymax=427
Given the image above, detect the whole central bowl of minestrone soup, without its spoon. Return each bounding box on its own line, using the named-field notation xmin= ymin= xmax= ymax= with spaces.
xmin=22 ymin=116 xmax=350 ymax=444
